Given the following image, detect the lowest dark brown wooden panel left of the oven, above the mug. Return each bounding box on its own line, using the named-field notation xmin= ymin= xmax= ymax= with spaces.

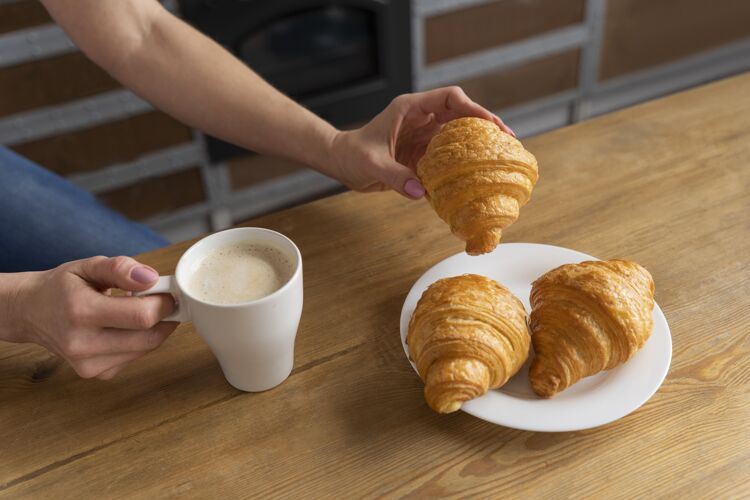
xmin=99 ymin=168 xmax=205 ymax=220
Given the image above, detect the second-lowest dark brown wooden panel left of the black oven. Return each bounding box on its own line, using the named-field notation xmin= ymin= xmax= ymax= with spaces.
xmin=12 ymin=111 xmax=192 ymax=175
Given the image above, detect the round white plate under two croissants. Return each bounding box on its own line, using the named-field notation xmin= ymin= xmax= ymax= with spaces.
xmin=401 ymin=243 xmax=672 ymax=432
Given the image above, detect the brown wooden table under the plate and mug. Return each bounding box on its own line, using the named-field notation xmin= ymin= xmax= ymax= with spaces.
xmin=0 ymin=75 xmax=750 ymax=498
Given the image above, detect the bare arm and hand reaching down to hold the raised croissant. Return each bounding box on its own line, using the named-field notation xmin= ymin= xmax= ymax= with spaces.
xmin=43 ymin=0 xmax=512 ymax=198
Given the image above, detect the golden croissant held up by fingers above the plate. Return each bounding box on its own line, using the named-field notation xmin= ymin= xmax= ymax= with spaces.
xmin=417 ymin=118 xmax=539 ymax=255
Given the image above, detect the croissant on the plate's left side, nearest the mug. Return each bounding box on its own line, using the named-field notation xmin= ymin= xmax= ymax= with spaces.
xmin=406 ymin=274 xmax=530 ymax=413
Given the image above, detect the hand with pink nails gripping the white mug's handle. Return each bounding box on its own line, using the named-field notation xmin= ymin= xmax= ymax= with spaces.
xmin=0 ymin=257 xmax=177 ymax=379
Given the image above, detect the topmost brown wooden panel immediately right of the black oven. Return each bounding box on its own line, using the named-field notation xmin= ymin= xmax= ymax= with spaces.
xmin=424 ymin=0 xmax=584 ymax=64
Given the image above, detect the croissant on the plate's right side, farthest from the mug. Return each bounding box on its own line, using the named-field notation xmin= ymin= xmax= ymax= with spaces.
xmin=529 ymin=260 xmax=654 ymax=398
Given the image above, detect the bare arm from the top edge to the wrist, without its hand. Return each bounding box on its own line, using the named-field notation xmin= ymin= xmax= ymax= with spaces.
xmin=47 ymin=0 xmax=336 ymax=173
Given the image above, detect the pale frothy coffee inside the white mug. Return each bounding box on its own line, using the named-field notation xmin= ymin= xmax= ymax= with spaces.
xmin=185 ymin=241 xmax=293 ymax=304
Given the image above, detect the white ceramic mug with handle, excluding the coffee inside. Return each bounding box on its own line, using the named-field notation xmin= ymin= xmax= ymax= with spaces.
xmin=139 ymin=227 xmax=302 ymax=392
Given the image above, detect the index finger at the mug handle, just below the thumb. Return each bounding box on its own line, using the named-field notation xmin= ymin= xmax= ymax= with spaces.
xmin=89 ymin=293 xmax=174 ymax=330
